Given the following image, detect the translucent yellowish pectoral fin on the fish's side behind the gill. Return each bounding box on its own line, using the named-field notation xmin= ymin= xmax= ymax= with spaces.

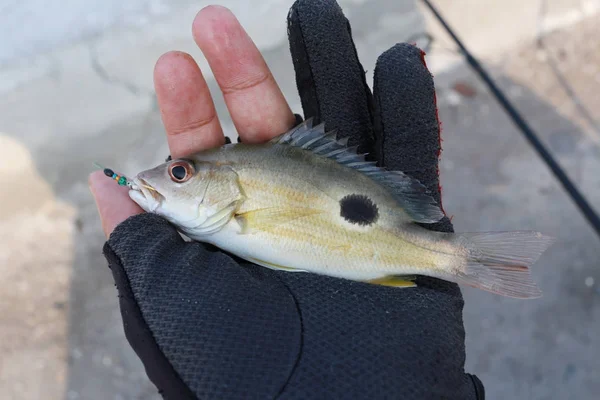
xmin=235 ymin=207 xmax=323 ymax=235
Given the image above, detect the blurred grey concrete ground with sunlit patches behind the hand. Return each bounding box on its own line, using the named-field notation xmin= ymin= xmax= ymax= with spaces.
xmin=0 ymin=0 xmax=600 ymax=400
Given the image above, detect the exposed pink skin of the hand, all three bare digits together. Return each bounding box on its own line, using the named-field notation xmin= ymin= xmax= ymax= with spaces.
xmin=89 ymin=7 xmax=295 ymax=237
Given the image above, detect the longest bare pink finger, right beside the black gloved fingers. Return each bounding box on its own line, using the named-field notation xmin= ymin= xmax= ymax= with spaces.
xmin=192 ymin=6 xmax=294 ymax=143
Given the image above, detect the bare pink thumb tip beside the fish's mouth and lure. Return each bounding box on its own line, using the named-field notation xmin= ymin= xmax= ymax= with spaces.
xmin=88 ymin=171 xmax=143 ymax=238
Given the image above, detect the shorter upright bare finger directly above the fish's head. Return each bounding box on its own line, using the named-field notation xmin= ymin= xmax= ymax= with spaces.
xmin=154 ymin=51 xmax=225 ymax=158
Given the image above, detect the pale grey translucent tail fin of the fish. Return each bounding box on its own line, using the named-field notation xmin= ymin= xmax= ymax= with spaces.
xmin=454 ymin=231 xmax=554 ymax=299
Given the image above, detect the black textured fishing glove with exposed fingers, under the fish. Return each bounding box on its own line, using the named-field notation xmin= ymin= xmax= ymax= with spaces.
xmin=104 ymin=0 xmax=484 ymax=400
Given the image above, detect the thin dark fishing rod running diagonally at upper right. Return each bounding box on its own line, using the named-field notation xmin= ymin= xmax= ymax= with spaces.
xmin=422 ymin=0 xmax=600 ymax=237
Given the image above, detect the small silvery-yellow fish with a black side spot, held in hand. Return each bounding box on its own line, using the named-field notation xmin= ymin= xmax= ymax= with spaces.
xmin=129 ymin=120 xmax=553 ymax=298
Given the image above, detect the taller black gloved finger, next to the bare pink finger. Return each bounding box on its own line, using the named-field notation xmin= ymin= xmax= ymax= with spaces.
xmin=288 ymin=0 xmax=373 ymax=152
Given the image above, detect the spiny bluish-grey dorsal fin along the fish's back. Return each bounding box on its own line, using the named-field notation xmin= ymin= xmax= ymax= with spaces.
xmin=270 ymin=118 xmax=444 ymax=223
